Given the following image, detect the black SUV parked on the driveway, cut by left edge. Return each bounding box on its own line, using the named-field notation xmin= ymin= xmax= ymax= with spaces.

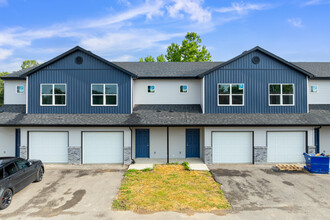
xmin=0 ymin=157 xmax=44 ymax=209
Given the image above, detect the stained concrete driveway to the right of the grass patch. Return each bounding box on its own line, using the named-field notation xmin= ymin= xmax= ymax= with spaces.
xmin=209 ymin=165 xmax=330 ymax=219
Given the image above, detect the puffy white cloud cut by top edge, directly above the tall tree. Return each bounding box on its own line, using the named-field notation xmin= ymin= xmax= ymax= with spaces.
xmin=166 ymin=0 xmax=212 ymax=23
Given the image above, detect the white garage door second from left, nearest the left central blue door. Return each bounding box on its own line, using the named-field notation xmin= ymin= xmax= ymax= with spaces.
xmin=83 ymin=132 xmax=124 ymax=164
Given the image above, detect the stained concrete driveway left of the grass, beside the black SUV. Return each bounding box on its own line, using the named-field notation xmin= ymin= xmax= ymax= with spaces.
xmin=0 ymin=165 xmax=127 ymax=219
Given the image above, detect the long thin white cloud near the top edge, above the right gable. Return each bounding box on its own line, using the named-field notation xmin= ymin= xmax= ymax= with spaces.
xmin=214 ymin=2 xmax=270 ymax=15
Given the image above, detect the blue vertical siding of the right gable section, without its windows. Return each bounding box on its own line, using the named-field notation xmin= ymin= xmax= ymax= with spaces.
xmin=205 ymin=51 xmax=307 ymax=113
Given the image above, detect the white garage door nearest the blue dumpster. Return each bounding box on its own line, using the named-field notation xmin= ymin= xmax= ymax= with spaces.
xmin=267 ymin=132 xmax=306 ymax=163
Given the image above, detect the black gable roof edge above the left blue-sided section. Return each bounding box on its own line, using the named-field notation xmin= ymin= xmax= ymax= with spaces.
xmin=20 ymin=46 xmax=136 ymax=78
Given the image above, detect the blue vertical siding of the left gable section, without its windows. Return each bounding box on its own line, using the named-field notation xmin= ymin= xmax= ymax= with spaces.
xmin=28 ymin=51 xmax=131 ymax=114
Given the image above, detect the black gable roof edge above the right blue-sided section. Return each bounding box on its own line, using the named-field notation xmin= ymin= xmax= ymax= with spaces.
xmin=199 ymin=46 xmax=314 ymax=77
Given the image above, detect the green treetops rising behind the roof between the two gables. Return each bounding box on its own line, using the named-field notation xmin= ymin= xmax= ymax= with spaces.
xmin=140 ymin=32 xmax=211 ymax=62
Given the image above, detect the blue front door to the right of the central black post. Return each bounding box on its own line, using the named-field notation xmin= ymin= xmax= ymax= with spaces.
xmin=186 ymin=129 xmax=200 ymax=157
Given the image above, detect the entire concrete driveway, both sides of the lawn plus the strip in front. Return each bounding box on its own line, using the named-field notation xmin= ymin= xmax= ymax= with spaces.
xmin=0 ymin=165 xmax=330 ymax=220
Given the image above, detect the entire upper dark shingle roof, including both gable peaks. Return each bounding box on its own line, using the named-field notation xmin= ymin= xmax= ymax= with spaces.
xmin=1 ymin=46 xmax=330 ymax=80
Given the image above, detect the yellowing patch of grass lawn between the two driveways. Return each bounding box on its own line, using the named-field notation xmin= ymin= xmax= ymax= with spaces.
xmin=112 ymin=165 xmax=231 ymax=212
